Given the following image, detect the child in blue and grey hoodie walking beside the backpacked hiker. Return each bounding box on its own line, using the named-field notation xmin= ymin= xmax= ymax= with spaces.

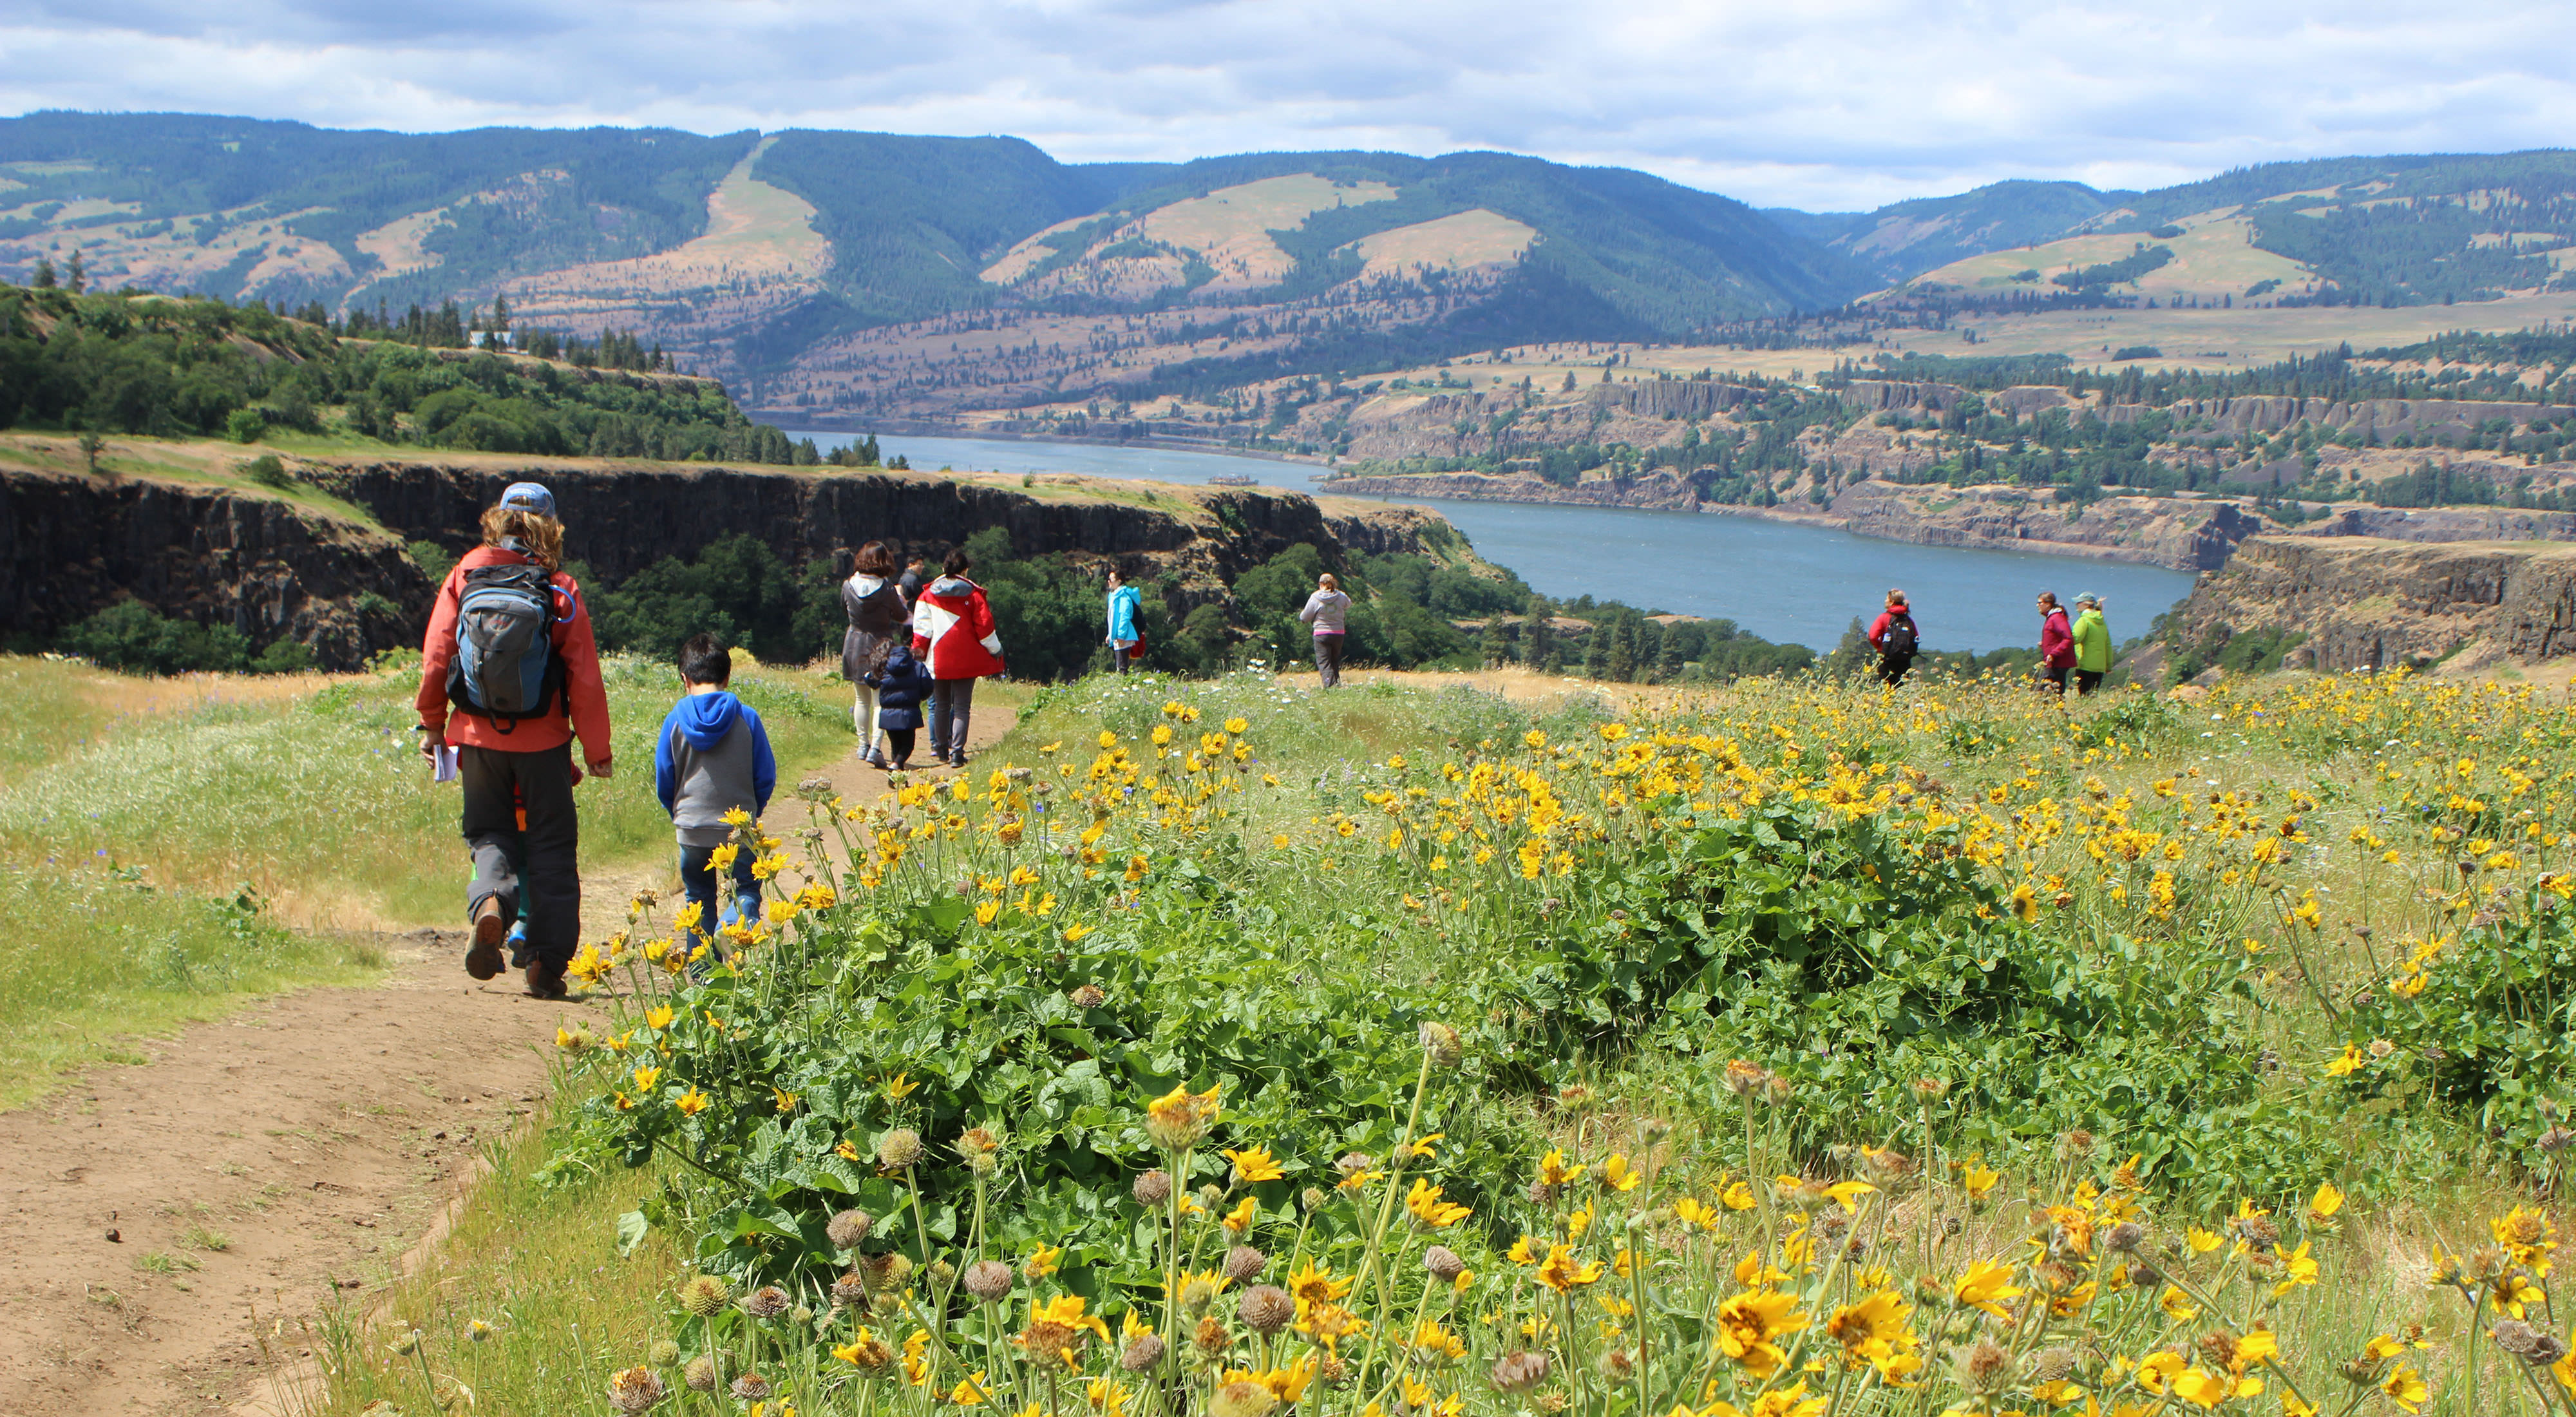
xmin=652 ymin=634 xmax=778 ymax=974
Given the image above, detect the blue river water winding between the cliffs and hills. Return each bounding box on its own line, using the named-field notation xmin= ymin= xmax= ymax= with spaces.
xmin=788 ymin=430 xmax=2192 ymax=652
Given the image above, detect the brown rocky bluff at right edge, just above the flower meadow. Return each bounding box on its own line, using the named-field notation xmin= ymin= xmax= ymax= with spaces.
xmin=2166 ymin=536 xmax=2576 ymax=672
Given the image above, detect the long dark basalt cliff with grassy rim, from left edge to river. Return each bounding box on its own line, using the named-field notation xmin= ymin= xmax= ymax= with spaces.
xmin=0 ymin=438 xmax=1466 ymax=670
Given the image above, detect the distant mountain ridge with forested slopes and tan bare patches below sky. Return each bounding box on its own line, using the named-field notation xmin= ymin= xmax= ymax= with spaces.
xmin=15 ymin=113 xmax=2576 ymax=415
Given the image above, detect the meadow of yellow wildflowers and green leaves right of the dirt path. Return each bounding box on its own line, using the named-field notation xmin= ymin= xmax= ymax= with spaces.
xmin=330 ymin=672 xmax=2576 ymax=1417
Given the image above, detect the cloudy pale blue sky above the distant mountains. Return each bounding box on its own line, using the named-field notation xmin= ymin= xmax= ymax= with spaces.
xmin=0 ymin=0 xmax=2576 ymax=209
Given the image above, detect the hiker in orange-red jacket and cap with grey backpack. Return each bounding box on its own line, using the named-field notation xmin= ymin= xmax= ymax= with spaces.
xmin=415 ymin=482 xmax=613 ymax=1000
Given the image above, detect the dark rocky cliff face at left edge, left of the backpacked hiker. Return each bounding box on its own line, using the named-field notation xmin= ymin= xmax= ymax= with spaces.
xmin=0 ymin=469 xmax=435 ymax=670
